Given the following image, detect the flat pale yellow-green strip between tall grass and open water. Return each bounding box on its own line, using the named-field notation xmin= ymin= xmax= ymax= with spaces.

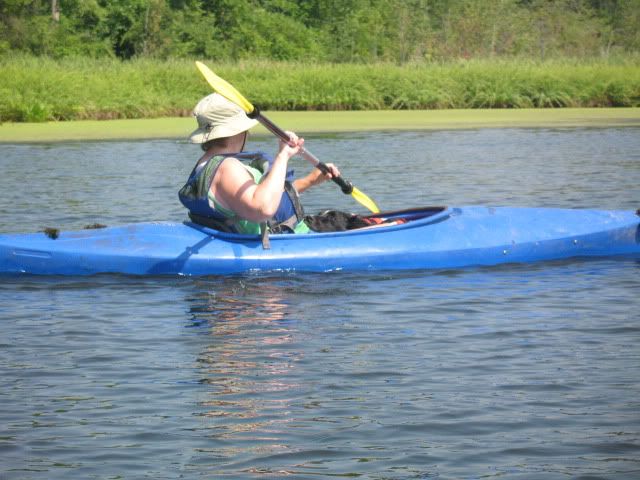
xmin=0 ymin=108 xmax=640 ymax=143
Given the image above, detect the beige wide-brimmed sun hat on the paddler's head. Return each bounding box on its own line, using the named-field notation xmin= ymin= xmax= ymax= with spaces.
xmin=189 ymin=93 xmax=258 ymax=143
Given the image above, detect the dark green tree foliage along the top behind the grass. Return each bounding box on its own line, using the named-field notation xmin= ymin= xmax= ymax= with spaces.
xmin=0 ymin=0 xmax=640 ymax=63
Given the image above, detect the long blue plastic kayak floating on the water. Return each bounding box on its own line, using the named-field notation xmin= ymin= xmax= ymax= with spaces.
xmin=0 ymin=206 xmax=640 ymax=275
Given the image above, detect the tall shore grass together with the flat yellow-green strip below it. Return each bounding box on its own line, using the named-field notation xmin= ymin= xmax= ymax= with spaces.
xmin=0 ymin=55 xmax=640 ymax=143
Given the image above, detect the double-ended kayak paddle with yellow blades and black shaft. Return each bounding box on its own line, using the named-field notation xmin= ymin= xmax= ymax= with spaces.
xmin=196 ymin=62 xmax=380 ymax=213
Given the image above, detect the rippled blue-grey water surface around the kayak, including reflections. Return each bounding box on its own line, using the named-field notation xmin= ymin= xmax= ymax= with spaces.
xmin=0 ymin=128 xmax=640 ymax=480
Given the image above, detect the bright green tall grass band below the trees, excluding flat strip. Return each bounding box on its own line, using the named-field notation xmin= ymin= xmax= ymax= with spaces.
xmin=0 ymin=57 xmax=640 ymax=122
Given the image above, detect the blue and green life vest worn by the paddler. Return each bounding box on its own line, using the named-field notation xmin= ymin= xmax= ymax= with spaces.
xmin=178 ymin=152 xmax=309 ymax=235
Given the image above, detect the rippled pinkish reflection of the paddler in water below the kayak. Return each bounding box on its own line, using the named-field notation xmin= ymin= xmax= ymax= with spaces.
xmin=186 ymin=279 xmax=304 ymax=457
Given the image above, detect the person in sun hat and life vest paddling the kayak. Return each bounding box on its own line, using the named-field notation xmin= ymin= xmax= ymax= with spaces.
xmin=179 ymin=93 xmax=340 ymax=234
